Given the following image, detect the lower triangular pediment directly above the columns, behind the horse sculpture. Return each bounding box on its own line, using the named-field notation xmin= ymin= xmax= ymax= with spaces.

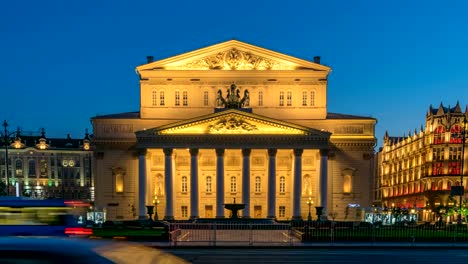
xmin=144 ymin=109 xmax=329 ymax=137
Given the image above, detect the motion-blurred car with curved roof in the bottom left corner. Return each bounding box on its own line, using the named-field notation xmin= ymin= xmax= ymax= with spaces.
xmin=0 ymin=236 xmax=189 ymax=264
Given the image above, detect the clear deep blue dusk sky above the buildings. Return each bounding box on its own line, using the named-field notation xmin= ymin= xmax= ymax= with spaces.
xmin=0 ymin=0 xmax=468 ymax=146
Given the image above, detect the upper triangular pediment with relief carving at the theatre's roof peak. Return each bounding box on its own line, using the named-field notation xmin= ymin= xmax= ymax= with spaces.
xmin=137 ymin=40 xmax=330 ymax=71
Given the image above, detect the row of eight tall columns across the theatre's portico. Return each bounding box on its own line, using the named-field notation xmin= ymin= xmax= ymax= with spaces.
xmin=138 ymin=148 xmax=328 ymax=220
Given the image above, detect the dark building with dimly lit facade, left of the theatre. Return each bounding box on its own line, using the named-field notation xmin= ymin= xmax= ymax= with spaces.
xmin=0 ymin=129 xmax=94 ymax=201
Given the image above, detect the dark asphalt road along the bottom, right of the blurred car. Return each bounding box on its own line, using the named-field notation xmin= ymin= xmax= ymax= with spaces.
xmin=164 ymin=247 xmax=468 ymax=264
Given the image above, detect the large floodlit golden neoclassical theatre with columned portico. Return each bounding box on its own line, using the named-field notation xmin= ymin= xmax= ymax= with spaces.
xmin=92 ymin=40 xmax=376 ymax=220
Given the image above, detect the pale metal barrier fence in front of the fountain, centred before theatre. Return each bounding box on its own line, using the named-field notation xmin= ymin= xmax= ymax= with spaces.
xmin=169 ymin=223 xmax=301 ymax=246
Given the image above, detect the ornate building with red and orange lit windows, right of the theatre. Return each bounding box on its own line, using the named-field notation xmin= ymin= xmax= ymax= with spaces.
xmin=376 ymin=102 xmax=468 ymax=221
